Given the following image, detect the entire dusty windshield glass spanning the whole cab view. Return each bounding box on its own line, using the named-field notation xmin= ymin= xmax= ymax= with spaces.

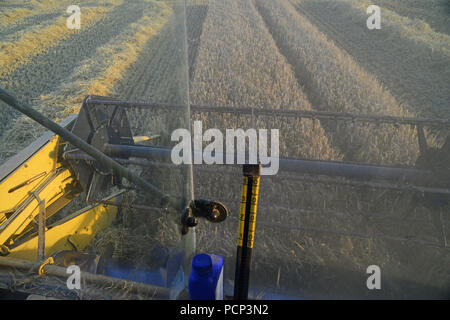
xmin=0 ymin=0 xmax=450 ymax=299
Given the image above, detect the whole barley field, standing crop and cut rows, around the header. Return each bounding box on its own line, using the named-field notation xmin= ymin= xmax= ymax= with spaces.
xmin=0 ymin=0 xmax=450 ymax=299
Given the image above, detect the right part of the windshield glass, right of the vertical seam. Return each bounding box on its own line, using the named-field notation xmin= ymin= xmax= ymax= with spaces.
xmin=188 ymin=0 xmax=450 ymax=299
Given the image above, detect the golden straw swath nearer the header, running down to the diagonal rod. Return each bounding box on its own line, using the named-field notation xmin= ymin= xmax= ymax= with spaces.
xmin=0 ymin=3 xmax=171 ymax=158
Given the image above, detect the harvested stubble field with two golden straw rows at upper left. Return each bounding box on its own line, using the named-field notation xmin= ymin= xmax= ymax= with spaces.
xmin=0 ymin=0 xmax=170 ymax=159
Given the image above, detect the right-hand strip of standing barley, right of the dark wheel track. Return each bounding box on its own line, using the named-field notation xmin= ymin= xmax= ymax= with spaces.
xmin=255 ymin=0 xmax=418 ymax=165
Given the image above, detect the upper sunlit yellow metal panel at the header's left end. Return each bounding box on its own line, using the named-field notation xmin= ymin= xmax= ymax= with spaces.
xmin=0 ymin=121 xmax=80 ymax=246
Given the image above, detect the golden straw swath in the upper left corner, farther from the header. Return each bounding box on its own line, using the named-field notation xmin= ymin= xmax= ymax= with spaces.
xmin=0 ymin=8 xmax=112 ymax=77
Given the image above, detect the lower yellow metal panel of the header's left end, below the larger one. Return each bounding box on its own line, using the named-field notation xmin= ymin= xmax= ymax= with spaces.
xmin=8 ymin=191 xmax=123 ymax=261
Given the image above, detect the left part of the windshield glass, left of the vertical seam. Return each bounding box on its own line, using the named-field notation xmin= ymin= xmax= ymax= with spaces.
xmin=0 ymin=0 xmax=195 ymax=299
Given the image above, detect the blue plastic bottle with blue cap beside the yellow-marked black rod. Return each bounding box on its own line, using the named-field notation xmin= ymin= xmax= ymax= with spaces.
xmin=189 ymin=254 xmax=224 ymax=300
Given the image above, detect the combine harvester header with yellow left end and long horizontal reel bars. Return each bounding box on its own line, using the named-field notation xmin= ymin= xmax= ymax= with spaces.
xmin=0 ymin=89 xmax=450 ymax=299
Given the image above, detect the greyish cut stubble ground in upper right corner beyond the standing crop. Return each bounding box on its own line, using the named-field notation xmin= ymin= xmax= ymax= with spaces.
xmin=291 ymin=0 xmax=450 ymax=124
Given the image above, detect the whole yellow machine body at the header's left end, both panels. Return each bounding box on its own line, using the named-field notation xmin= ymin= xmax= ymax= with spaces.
xmin=0 ymin=116 xmax=122 ymax=261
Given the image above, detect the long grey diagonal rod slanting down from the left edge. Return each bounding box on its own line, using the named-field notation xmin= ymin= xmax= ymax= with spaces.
xmin=0 ymin=88 xmax=171 ymax=210
